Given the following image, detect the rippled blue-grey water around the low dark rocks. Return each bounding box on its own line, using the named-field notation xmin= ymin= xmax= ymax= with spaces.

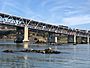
xmin=0 ymin=42 xmax=90 ymax=68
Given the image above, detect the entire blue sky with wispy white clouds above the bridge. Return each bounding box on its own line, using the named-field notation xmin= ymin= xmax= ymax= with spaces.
xmin=0 ymin=0 xmax=90 ymax=26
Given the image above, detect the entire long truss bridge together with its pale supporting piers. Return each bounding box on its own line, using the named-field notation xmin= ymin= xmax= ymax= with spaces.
xmin=0 ymin=13 xmax=90 ymax=47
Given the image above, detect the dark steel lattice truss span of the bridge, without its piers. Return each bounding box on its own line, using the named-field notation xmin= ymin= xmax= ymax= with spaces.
xmin=0 ymin=13 xmax=90 ymax=37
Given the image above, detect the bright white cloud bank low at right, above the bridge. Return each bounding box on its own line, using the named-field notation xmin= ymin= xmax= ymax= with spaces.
xmin=63 ymin=15 xmax=90 ymax=25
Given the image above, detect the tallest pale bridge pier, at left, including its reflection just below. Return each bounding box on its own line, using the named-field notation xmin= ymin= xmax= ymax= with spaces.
xmin=23 ymin=24 xmax=29 ymax=49
